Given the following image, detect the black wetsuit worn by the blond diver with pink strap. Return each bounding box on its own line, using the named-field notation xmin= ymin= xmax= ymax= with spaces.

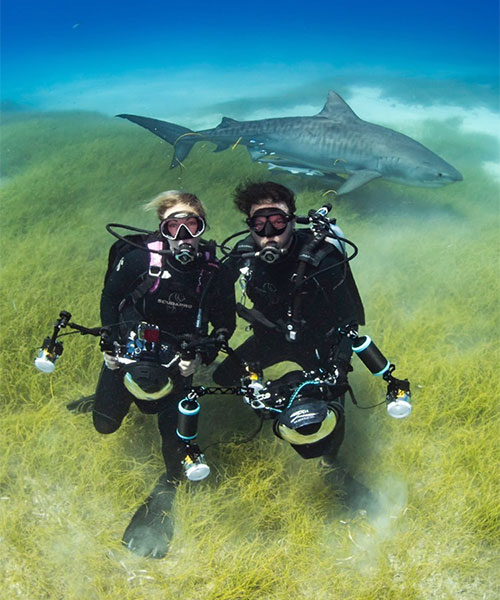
xmin=93 ymin=244 xmax=235 ymax=480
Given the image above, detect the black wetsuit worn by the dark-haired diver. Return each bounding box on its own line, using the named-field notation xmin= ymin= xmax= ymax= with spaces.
xmin=213 ymin=230 xmax=364 ymax=456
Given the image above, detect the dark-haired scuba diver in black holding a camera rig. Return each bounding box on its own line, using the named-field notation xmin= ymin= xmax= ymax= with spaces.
xmin=213 ymin=182 xmax=364 ymax=464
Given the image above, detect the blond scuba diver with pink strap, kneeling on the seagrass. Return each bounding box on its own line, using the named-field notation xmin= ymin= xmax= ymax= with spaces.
xmin=93 ymin=190 xmax=235 ymax=558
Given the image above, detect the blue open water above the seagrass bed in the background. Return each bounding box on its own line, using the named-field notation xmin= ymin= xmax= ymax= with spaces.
xmin=1 ymin=0 xmax=498 ymax=117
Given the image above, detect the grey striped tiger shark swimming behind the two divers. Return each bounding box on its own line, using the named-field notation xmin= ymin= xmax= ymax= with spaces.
xmin=117 ymin=91 xmax=462 ymax=196
